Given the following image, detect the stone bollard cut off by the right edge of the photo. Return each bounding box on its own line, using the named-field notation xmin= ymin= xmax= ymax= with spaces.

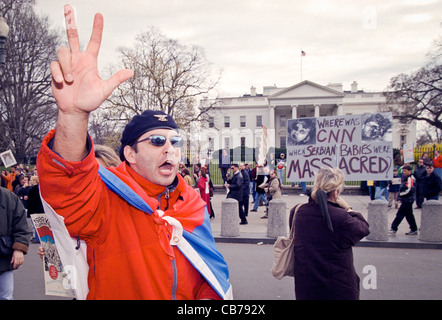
xmin=419 ymin=200 xmax=442 ymax=242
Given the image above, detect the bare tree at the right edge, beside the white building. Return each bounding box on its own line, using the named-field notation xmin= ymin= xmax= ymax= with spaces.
xmin=383 ymin=38 xmax=442 ymax=139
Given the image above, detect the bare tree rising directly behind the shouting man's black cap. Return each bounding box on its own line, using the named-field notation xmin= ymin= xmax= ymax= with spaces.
xmin=105 ymin=28 xmax=220 ymax=128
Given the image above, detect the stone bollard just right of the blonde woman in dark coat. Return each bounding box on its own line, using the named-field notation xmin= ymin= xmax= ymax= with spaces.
xmin=367 ymin=200 xmax=388 ymax=241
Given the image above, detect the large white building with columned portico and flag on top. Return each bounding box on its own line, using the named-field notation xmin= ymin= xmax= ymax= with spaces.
xmin=200 ymin=80 xmax=416 ymax=158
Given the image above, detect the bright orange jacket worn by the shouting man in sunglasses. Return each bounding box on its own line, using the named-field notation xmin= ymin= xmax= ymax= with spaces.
xmin=37 ymin=130 xmax=231 ymax=299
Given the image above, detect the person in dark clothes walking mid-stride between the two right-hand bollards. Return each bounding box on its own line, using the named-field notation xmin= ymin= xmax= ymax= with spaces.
xmin=390 ymin=165 xmax=417 ymax=235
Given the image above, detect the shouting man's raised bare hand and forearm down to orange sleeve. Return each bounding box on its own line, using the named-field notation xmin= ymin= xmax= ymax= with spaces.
xmin=51 ymin=5 xmax=133 ymax=161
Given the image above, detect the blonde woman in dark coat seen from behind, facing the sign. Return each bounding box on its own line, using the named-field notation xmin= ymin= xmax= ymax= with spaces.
xmin=290 ymin=168 xmax=370 ymax=300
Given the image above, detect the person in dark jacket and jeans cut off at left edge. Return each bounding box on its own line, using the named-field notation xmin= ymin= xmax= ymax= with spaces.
xmin=0 ymin=187 xmax=31 ymax=300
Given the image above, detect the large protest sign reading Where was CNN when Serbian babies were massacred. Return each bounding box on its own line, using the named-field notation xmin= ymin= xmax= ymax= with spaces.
xmin=287 ymin=113 xmax=393 ymax=182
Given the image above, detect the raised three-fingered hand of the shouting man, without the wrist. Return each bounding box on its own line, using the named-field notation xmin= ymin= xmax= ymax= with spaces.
xmin=51 ymin=5 xmax=133 ymax=113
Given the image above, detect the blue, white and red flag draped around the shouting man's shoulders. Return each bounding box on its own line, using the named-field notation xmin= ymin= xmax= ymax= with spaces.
xmin=98 ymin=166 xmax=232 ymax=299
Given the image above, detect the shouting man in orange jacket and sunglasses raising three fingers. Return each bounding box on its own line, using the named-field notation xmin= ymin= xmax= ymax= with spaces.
xmin=37 ymin=5 xmax=231 ymax=299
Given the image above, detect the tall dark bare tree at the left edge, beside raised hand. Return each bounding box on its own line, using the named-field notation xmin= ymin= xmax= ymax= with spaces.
xmin=0 ymin=0 xmax=60 ymax=162
